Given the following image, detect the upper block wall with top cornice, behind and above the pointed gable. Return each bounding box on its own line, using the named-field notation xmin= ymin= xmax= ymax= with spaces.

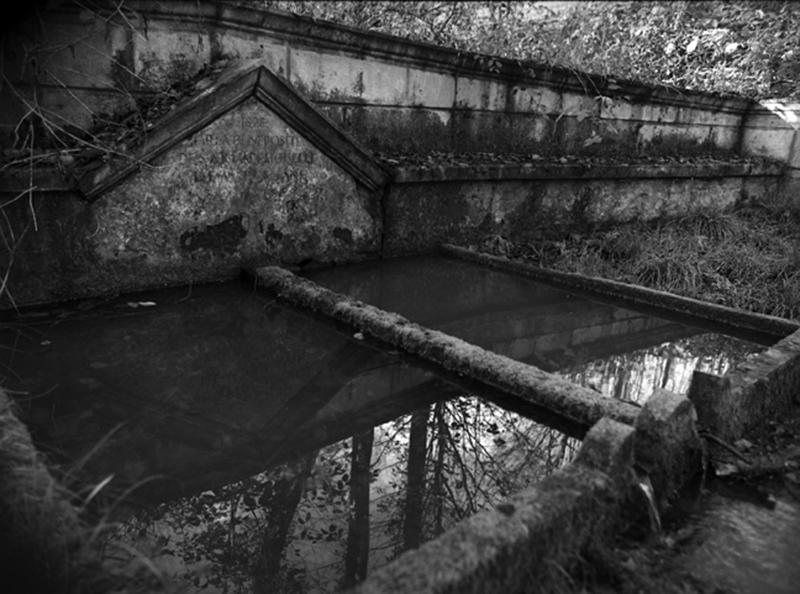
xmin=0 ymin=0 xmax=771 ymax=160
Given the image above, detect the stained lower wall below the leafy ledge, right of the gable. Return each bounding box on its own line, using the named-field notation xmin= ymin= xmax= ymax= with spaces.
xmin=384 ymin=167 xmax=781 ymax=255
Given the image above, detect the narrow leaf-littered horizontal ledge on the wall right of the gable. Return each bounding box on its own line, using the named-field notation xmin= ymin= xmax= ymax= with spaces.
xmin=392 ymin=161 xmax=784 ymax=184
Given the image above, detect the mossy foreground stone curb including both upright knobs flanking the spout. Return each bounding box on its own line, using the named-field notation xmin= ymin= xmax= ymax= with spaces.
xmin=344 ymin=390 xmax=702 ymax=594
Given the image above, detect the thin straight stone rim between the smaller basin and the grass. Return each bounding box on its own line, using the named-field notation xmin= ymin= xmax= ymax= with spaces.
xmin=440 ymin=244 xmax=800 ymax=343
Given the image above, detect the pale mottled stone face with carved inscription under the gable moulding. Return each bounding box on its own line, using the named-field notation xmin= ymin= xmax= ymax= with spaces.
xmin=92 ymin=99 xmax=379 ymax=266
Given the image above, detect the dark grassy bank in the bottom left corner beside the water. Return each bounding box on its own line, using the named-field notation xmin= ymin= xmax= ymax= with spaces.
xmin=0 ymin=389 xmax=176 ymax=594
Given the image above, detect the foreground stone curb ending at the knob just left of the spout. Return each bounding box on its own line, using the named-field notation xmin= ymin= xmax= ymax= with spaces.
xmin=351 ymin=418 xmax=635 ymax=594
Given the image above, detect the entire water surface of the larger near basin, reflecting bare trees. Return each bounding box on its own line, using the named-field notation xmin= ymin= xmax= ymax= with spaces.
xmin=1 ymin=284 xmax=579 ymax=592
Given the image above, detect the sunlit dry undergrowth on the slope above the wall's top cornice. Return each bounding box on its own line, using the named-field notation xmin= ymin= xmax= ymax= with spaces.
xmin=261 ymin=0 xmax=800 ymax=98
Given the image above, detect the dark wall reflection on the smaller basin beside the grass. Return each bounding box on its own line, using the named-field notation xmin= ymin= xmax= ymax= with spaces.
xmin=308 ymin=256 xmax=761 ymax=372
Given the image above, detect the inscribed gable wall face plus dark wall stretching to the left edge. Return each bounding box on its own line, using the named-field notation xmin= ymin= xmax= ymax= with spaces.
xmin=0 ymin=92 xmax=381 ymax=305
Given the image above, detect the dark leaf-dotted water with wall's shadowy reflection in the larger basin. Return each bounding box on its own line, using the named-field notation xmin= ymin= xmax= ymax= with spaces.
xmin=0 ymin=285 xmax=446 ymax=501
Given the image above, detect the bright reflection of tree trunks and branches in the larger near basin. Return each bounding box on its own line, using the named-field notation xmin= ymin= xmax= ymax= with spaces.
xmin=109 ymin=397 xmax=578 ymax=592
